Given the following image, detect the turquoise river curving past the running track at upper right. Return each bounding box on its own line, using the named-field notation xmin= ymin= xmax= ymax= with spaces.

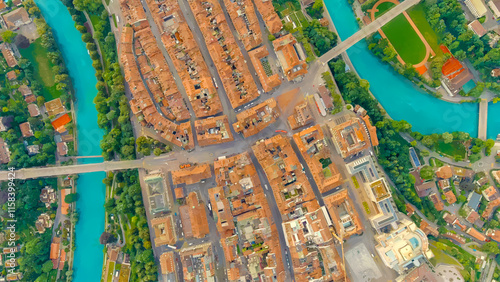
xmin=325 ymin=0 xmax=500 ymax=138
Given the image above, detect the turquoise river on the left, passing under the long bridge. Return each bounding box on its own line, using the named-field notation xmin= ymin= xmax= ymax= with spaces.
xmin=35 ymin=0 xmax=105 ymax=282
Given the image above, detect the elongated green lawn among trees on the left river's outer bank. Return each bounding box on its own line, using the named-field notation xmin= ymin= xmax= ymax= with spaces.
xmin=19 ymin=38 xmax=62 ymax=101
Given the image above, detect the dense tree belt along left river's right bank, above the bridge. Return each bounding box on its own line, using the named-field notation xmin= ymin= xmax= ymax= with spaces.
xmin=63 ymin=0 xmax=135 ymax=160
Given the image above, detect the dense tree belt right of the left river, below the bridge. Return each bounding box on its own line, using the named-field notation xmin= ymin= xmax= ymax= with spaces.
xmin=103 ymin=170 xmax=158 ymax=282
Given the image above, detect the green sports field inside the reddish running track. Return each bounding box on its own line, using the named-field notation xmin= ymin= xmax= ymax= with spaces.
xmin=382 ymin=14 xmax=426 ymax=65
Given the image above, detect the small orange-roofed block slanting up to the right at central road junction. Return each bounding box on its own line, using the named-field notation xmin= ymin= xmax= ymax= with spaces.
xmin=233 ymin=98 xmax=281 ymax=138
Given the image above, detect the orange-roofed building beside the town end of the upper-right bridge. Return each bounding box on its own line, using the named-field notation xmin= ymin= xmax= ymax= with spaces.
xmin=273 ymin=33 xmax=307 ymax=81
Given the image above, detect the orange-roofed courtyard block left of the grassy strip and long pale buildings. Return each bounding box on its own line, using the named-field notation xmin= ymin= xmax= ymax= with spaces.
xmin=324 ymin=189 xmax=364 ymax=240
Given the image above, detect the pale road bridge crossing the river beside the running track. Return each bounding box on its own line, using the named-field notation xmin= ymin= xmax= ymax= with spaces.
xmin=318 ymin=0 xmax=420 ymax=64
